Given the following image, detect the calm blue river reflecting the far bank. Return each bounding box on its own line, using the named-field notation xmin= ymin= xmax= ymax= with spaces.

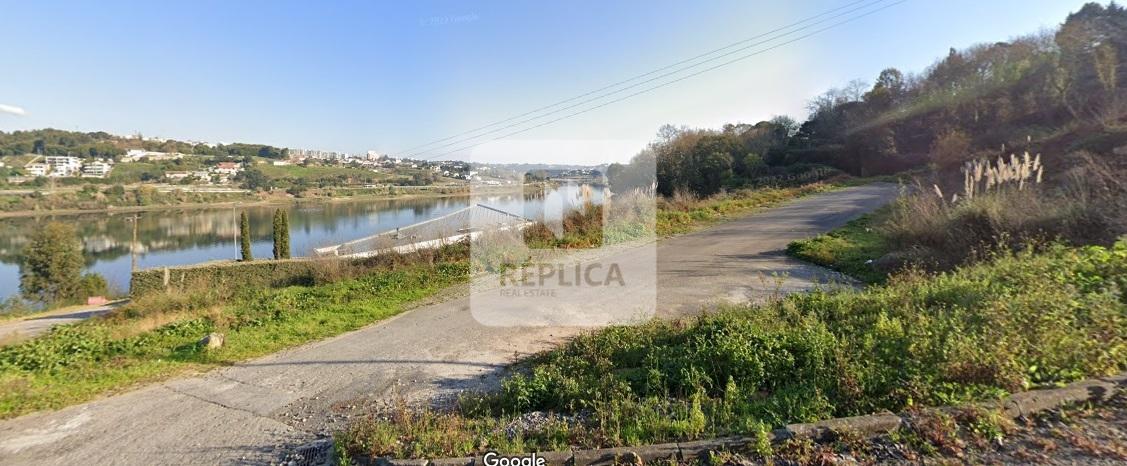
xmin=0 ymin=184 xmax=601 ymax=299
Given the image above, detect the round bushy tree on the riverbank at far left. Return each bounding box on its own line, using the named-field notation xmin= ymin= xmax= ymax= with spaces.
xmin=19 ymin=221 xmax=82 ymax=304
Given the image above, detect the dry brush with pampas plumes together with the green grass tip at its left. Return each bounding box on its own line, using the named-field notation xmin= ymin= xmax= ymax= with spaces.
xmin=788 ymin=152 xmax=1127 ymax=279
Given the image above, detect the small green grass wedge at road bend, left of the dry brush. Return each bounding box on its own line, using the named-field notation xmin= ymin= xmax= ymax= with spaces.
xmin=787 ymin=208 xmax=889 ymax=283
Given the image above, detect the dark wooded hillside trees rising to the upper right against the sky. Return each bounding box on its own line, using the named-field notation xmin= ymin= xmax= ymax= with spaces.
xmin=607 ymin=3 xmax=1127 ymax=195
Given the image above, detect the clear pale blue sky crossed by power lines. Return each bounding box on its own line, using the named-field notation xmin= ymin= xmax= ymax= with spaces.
xmin=0 ymin=0 xmax=1099 ymax=164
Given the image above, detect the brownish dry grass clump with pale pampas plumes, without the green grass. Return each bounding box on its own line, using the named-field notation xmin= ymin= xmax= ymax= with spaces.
xmin=879 ymin=153 xmax=1127 ymax=270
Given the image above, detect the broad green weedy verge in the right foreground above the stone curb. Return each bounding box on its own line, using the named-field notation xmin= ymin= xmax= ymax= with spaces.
xmin=337 ymin=241 xmax=1127 ymax=457
